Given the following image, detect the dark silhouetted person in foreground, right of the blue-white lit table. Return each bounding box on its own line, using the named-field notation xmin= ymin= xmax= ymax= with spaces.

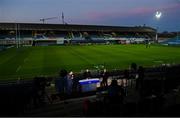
xmin=108 ymin=80 xmax=124 ymax=103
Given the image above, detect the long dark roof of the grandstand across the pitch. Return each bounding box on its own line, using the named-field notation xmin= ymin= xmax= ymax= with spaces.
xmin=0 ymin=23 xmax=156 ymax=33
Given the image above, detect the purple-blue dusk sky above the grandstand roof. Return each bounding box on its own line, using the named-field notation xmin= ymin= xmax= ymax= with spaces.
xmin=0 ymin=0 xmax=180 ymax=31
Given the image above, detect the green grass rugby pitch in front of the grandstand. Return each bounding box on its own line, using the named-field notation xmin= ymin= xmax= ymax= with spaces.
xmin=0 ymin=45 xmax=180 ymax=80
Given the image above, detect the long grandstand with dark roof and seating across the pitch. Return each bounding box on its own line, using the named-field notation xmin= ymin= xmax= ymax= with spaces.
xmin=0 ymin=23 xmax=156 ymax=45
